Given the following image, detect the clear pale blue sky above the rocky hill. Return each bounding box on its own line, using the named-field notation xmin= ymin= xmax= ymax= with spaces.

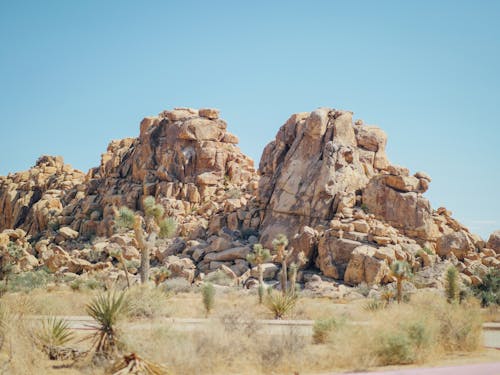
xmin=0 ymin=0 xmax=500 ymax=238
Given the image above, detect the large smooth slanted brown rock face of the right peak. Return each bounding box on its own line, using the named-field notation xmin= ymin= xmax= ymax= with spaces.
xmin=259 ymin=108 xmax=378 ymax=247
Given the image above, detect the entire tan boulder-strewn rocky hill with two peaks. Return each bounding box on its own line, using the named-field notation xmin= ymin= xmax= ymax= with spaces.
xmin=0 ymin=108 xmax=500 ymax=292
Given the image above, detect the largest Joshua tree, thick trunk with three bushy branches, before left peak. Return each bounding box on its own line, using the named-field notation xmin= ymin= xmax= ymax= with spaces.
xmin=116 ymin=196 xmax=177 ymax=283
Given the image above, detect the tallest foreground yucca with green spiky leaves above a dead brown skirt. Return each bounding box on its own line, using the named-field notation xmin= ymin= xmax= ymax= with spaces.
xmin=86 ymin=292 xmax=127 ymax=358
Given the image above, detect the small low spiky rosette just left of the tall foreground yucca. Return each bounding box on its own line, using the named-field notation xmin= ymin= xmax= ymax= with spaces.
xmin=35 ymin=317 xmax=75 ymax=359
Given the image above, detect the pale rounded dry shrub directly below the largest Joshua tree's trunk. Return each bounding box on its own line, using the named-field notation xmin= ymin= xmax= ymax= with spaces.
xmin=126 ymin=284 xmax=168 ymax=318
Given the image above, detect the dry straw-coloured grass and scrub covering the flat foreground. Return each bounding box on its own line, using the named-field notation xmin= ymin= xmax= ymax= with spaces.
xmin=0 ymin=286 xmax=492 ymax=375
